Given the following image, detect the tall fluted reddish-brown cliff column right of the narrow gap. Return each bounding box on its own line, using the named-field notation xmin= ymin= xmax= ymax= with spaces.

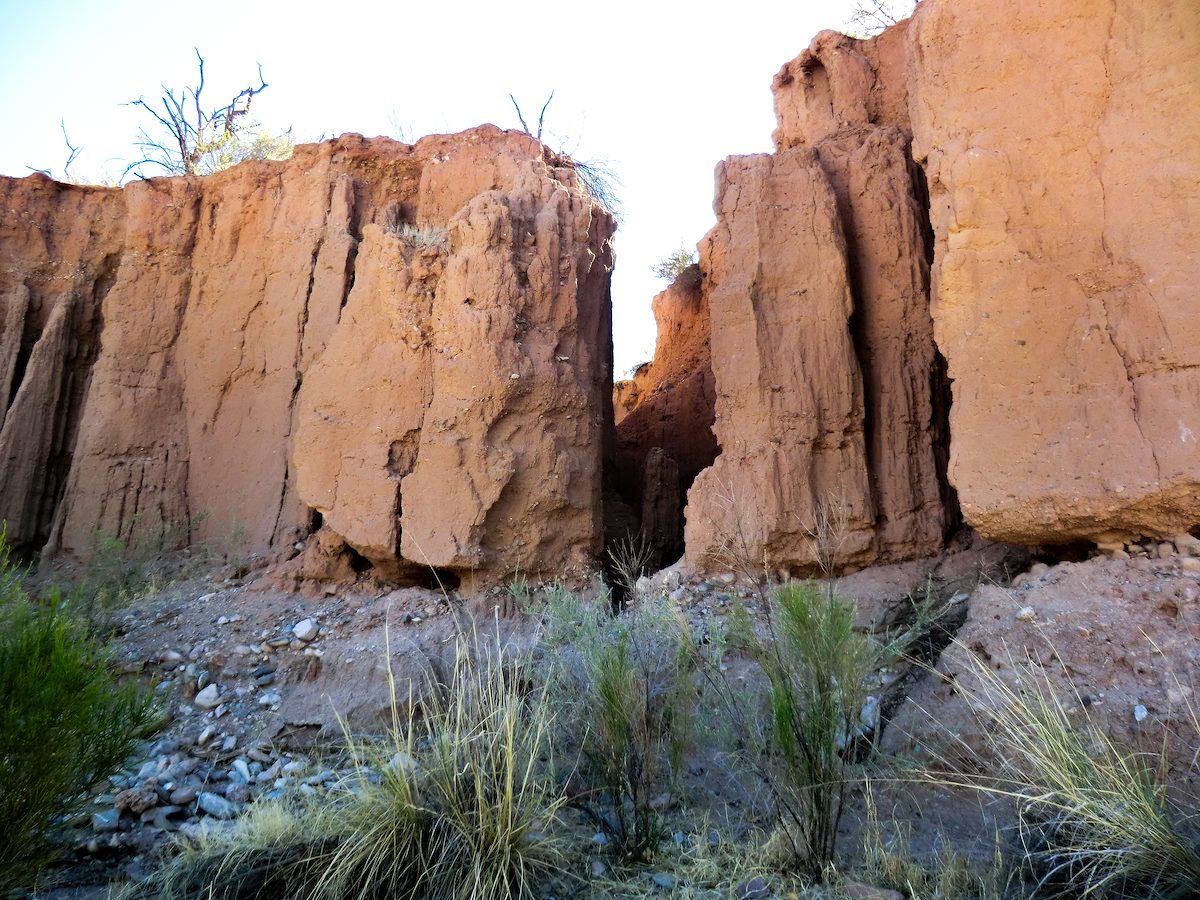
xmin=686 ymin=22 xmax=955 ymax=571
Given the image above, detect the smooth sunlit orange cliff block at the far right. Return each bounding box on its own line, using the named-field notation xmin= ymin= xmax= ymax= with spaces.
xmin=908 ymin=0 xmax=1200 ymax=544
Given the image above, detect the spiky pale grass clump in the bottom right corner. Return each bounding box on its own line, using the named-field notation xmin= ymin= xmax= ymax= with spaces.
xmin=937 ymin=653 xmax=1200 ymax=900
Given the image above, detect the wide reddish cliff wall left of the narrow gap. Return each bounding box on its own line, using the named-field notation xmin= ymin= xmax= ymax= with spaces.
xmin=0 ymin=126 xmax=613 ymax=592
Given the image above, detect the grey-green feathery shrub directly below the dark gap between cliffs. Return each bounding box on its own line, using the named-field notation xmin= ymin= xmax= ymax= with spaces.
xmin=546 ymin=594 xmax=697 ymax=860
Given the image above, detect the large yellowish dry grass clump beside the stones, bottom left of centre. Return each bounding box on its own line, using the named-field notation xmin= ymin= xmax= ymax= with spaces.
xmin=146 ymin=638 xmax=563 ymax=900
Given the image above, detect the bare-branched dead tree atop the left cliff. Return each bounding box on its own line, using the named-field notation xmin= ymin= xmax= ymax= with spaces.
xmin=122 ymin=48 xmax=269 ymax=178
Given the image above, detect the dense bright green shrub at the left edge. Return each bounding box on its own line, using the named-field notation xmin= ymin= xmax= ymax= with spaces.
xmin=0 ymin=536 xmax=154 ymax=893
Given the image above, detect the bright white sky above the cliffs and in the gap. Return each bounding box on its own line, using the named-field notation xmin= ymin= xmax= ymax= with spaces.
xmin=0 ymin=0 xmax=873 ymax=374
